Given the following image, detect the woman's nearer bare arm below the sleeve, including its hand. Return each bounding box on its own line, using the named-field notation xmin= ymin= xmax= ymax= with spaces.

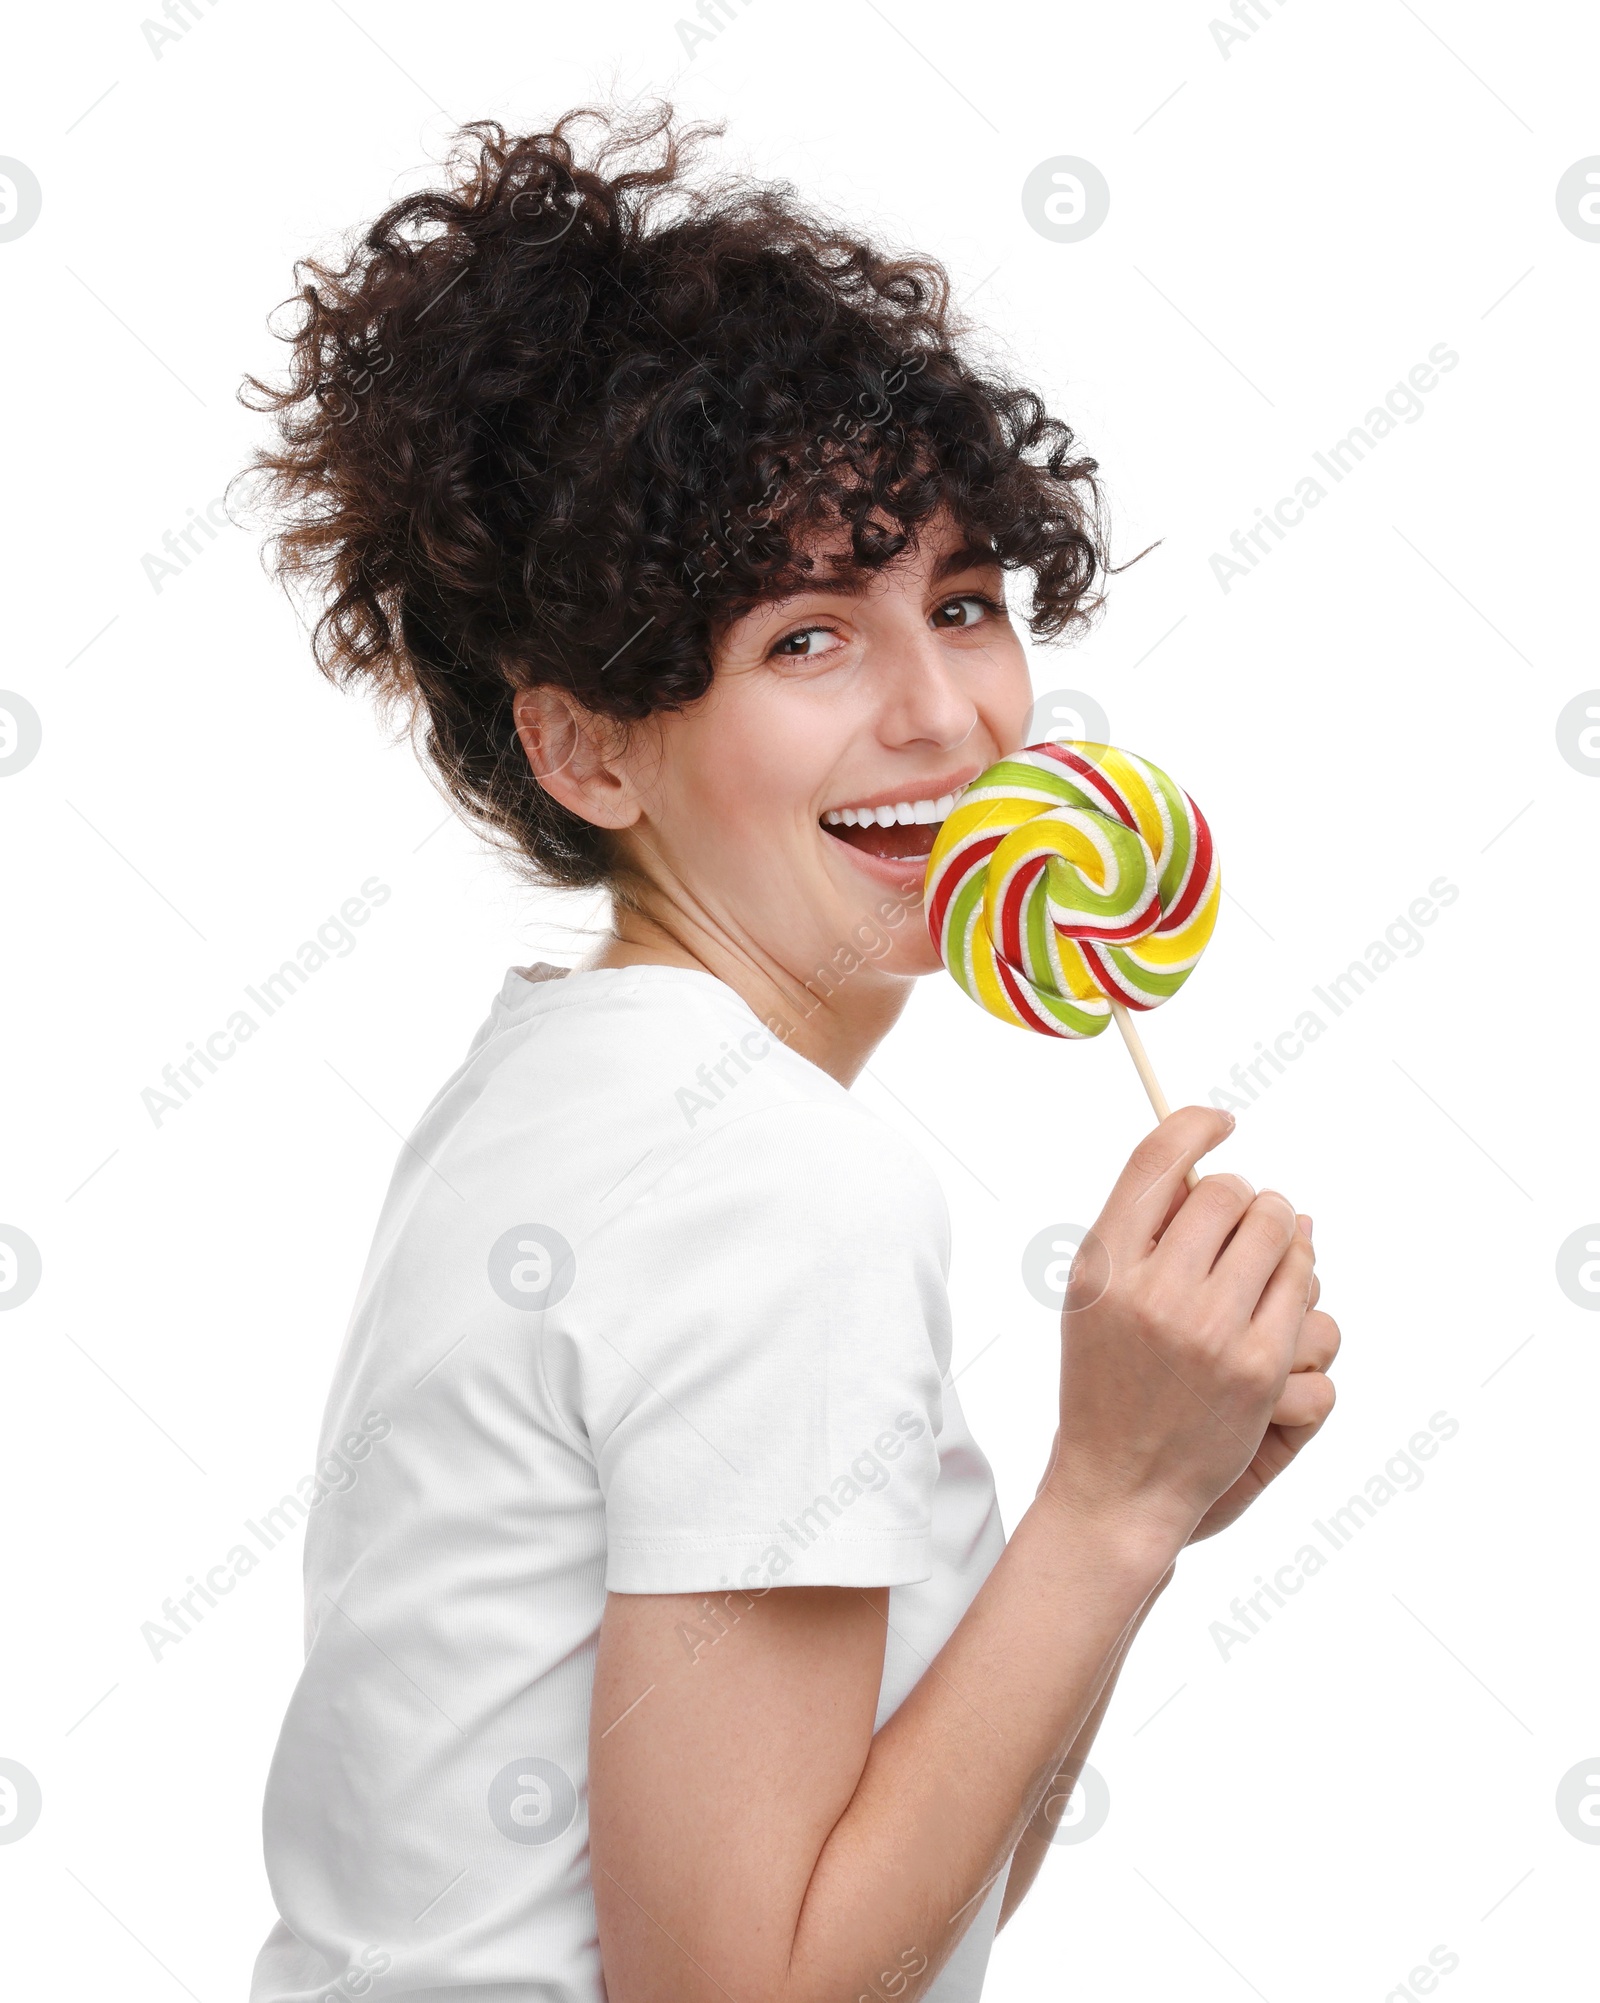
xmin=589 ymin=1108 xmax=1332 ymax=2003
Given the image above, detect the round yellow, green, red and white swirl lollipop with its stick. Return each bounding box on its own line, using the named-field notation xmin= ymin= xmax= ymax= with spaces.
xmin=925 ymin=743 xmax=1222 ymax=1169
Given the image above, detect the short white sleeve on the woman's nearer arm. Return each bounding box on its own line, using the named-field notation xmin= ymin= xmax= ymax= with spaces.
xmin=569 ymin=1100 xmax=949 ymax=1592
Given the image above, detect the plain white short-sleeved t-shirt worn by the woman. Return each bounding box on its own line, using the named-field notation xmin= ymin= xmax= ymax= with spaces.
xmin=250 ymin=967 xmax=1003 ymax=2003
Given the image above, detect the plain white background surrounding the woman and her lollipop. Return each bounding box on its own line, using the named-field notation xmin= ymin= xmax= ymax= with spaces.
xmin=0 ymin=0 xmax=1600 ymax=2003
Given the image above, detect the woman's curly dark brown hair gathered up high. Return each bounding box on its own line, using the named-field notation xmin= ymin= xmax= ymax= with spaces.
xmin=240 ymin=104 xmax=1109 ymax=887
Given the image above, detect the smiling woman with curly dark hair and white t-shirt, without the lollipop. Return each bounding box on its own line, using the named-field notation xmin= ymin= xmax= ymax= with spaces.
xmin=241 ymin=112 xmax=1338 ymax=2003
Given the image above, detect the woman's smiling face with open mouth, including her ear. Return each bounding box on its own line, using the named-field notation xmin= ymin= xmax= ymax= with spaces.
xmin=608 ymin=517 xmax=1031 ymax=983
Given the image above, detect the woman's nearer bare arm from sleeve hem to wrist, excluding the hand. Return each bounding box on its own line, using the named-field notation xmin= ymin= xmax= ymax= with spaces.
xmin=589 ymin=1496 xmax=1173 ymax=2003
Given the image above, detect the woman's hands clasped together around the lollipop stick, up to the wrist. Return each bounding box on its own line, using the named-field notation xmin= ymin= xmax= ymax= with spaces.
xmin=1041 ymin=1106 xmax=1338 ymax=1544
